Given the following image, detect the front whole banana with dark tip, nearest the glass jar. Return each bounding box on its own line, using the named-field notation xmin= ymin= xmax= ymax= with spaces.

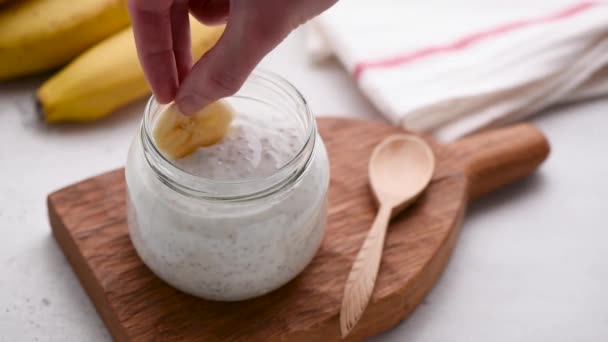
xmin=37 ymin=18 xmax=224 ymax=122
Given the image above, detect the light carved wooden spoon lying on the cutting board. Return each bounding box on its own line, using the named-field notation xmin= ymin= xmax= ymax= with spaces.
xmin=340 ymin=134 xmax=435 ymax=337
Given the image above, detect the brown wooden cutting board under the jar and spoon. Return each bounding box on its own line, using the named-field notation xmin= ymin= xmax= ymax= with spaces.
xmin=48 ymin=118 xmax=549 ymax=342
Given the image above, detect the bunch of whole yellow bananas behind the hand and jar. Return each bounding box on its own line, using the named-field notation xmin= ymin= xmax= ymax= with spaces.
xmin=0 ymin=0 xmax=223 ymax=122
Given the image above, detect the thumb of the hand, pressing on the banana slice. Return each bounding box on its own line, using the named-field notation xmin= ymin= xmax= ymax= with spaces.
xmin=175 ymin=8 xmax=289 ymax=114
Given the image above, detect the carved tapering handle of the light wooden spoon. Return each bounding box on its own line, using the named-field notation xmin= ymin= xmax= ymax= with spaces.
xmin=340 ymin=205 xmax=391 ymax=338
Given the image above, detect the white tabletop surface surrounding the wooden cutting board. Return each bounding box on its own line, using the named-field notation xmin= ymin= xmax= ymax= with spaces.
xmin=0 ymin=27 xmax=608 ymax=342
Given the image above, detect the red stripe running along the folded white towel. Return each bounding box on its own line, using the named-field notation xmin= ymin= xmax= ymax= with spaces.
xmin=353 ymin=1 xmax=601 ymax=80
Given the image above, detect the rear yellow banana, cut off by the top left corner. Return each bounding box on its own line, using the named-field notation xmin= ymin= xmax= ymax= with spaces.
xmin=0 ymin=0 xmax=129 ymax=80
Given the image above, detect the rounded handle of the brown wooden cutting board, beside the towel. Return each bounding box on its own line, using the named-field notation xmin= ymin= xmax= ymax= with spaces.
xmin=449 ymin=124 xmax=550 ymax=199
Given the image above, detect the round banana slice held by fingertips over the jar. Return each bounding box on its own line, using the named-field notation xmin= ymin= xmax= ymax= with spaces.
xmin=153 ymin=101 xmax=234 ymax=159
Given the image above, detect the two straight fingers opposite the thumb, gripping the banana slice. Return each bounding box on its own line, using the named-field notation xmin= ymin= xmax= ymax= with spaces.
xmin=128 ymin=0 xmax=192 ymax=103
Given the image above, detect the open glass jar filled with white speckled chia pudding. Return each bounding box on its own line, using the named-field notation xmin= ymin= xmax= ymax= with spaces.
xmin=126 ymin=71 xmax=329 ymax=301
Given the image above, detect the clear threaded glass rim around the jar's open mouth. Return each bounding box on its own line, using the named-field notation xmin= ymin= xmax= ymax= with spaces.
xmin=140 ymin=69 xmax=317 ymax=201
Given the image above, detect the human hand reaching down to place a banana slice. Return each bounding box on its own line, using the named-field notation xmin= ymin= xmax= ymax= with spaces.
xmin=129 ymin=0 xmax=337 ymax=114
